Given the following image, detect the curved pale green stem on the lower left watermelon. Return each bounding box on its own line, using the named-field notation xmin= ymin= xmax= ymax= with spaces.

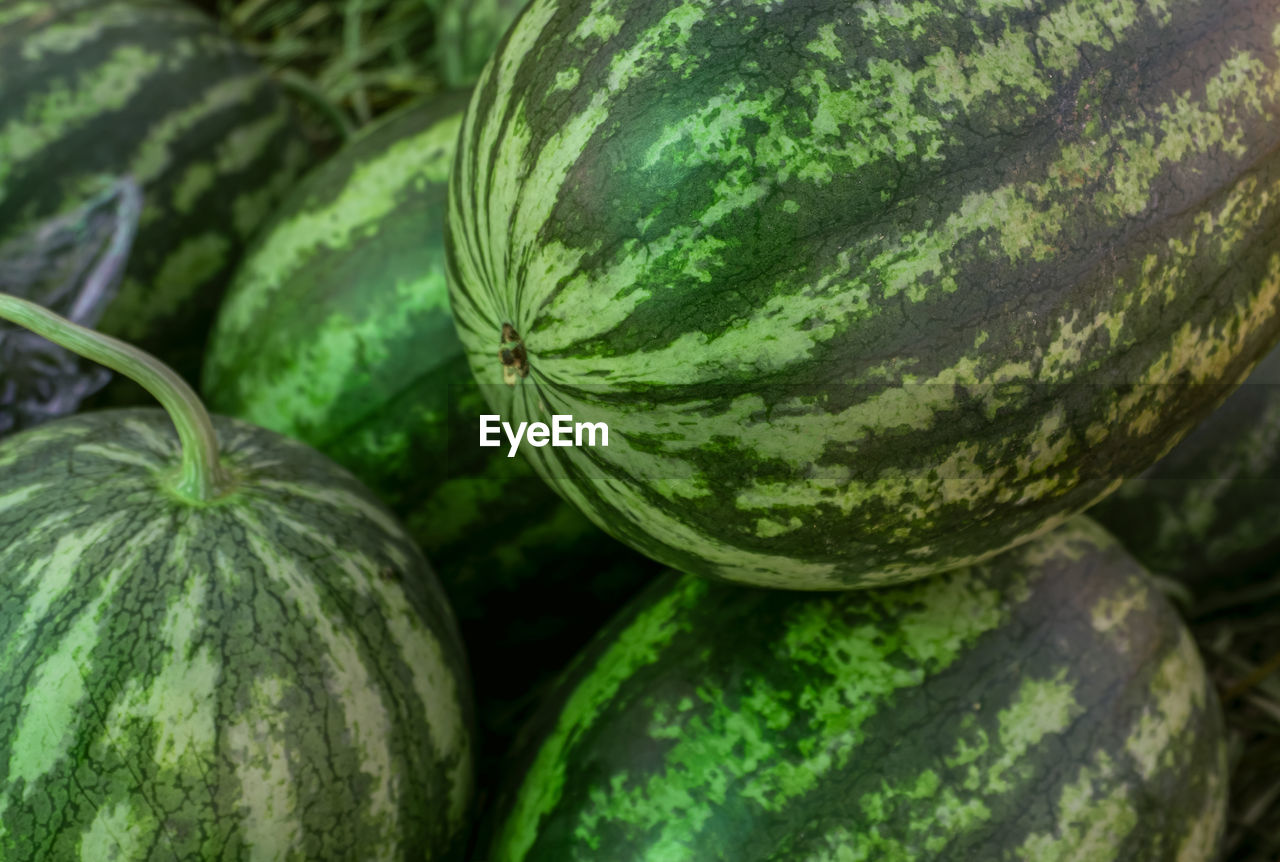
xmin=0 ymin=292 xmax=232 ymax=503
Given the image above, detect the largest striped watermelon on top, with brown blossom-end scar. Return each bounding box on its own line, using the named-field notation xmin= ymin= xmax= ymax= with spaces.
xmin=448 ymin=0 xmax=1280 ymax=589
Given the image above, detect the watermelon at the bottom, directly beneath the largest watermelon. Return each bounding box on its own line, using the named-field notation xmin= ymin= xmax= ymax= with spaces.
xmin=476 ymin=516 xmax=1228 ymax=862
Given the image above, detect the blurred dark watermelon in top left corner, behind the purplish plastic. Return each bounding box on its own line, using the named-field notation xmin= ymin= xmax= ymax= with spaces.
xmin=0 ymin=0 xmax=311 ymax=391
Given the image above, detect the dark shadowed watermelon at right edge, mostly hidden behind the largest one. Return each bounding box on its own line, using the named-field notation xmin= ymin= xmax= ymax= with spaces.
xmin=1089 ymin=348 xmax=1280 ymax=590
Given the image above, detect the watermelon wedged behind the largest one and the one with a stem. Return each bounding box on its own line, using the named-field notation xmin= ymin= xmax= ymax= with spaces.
xmin=204 ymin=94 xmax=659 ymax=771
